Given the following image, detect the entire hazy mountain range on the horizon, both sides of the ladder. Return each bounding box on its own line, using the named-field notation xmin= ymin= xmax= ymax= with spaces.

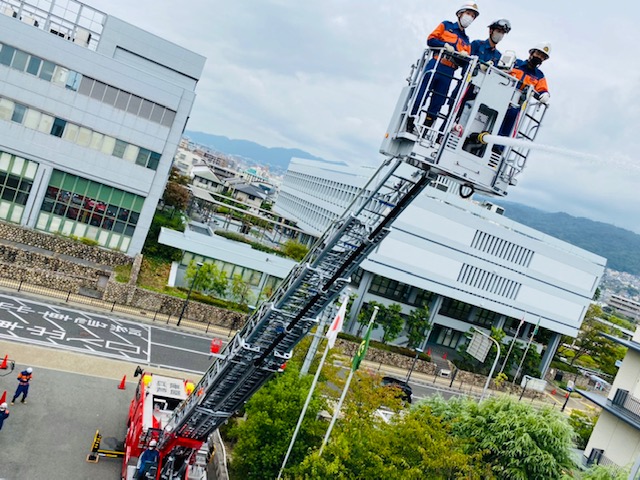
xmin=185 ymin=131 xmax=640 ymax=276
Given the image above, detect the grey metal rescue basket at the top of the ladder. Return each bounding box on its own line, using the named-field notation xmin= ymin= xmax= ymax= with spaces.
xmin=380 ymin=48 xmax=547 ymax=197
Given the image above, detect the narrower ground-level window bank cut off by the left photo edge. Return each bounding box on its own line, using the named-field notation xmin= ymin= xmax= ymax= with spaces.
xmin=0 ymin=152 xmax=38 ymax=223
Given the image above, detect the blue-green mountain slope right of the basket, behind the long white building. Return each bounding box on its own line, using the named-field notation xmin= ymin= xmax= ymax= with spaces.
xmin=490 ymin=199 xmax=640 ymax=276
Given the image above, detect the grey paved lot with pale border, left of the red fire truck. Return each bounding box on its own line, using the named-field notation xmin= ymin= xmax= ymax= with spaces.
xmin=0 ymin=341 xmax=195 ymax=480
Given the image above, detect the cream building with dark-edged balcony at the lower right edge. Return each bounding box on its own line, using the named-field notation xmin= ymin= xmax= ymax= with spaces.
xmin=578 ymin=327 xmax=640 ymax=468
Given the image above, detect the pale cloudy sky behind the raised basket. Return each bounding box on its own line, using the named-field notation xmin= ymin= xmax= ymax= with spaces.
xmin=86 ymin=0 xmax=640 ymax=234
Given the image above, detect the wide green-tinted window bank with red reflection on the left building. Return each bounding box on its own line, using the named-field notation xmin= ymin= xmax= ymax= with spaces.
xmin=36 ymin=170 xmax=144 ymax=251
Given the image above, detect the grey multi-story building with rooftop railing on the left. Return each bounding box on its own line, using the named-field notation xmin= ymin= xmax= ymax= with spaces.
xmin=0 ymin=0 xmax=205 ymax=255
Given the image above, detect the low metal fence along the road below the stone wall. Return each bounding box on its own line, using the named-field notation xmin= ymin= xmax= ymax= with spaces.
xmin=0 ymin=277 xmax=233 ymax=336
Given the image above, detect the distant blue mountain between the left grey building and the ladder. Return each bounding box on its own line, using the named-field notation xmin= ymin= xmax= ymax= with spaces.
xmin=184 ymin=130 xmax=324 ymax=174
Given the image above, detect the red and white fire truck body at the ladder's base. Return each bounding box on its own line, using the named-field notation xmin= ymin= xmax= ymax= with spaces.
xmin=122 ymin=367 xmax=210 ymax=480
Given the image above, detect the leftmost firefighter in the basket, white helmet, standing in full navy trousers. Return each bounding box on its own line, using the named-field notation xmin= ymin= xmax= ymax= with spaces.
xmin=407 ymin=2 xmax=480 ymax=131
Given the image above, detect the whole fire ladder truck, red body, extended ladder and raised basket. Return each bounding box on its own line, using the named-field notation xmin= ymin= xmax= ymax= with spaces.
xmin=94 ymin=49 xmax=546 ymax=480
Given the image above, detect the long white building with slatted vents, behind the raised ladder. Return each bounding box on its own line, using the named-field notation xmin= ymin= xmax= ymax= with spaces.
xmin=274 ymin=159 xmax=605 ymax=372
